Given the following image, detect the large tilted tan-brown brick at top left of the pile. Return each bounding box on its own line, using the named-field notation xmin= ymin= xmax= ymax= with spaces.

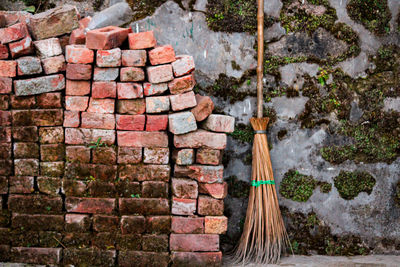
xmin=29 ymin=5 xmax=79 ymax=40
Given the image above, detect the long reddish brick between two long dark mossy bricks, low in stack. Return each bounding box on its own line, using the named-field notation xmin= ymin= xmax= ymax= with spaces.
xmin=65 ymin=197 xmax=115 ymax=214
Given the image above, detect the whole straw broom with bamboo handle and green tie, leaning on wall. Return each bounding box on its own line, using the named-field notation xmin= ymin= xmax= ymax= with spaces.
xmin=232 ymin=0 xmax=290 ymax=264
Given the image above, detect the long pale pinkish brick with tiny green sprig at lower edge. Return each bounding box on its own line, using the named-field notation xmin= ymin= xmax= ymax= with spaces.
xmin=65 ymin=128 xmax=115 ymax=145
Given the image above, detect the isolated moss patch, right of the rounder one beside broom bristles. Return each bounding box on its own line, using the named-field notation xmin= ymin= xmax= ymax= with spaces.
xmin=333 ymin=171 xmax=376 ymax=200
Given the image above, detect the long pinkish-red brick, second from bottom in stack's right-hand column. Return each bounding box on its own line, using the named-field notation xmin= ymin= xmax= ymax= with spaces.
xmin=169 ymin=234 xmax=219 ymax=251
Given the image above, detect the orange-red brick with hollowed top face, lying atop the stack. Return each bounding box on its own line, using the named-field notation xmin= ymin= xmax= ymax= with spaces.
xmin=86 ymin=26 xmax=129 ymax=49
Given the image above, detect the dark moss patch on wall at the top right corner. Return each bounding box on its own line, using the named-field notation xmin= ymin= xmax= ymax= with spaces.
xmin=347 ymin=0 xmax=391 ymax=35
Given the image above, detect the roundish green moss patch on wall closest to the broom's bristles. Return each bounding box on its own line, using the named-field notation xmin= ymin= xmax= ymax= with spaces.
xmin=279 ymin=170 xmax=317 ymax=202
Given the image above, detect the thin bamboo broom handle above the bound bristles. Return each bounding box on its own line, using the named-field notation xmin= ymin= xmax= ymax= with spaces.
xmin=257 ymin=0 xmax=264 ymax=118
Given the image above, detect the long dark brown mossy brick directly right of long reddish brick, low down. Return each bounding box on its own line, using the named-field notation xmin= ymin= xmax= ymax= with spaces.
xmin=119 ymin=198 xmax=169 ymax=215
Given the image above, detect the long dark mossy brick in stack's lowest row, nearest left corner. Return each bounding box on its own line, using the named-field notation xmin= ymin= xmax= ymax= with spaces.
xmin=11 ymin=247 xmax=62 ymax=265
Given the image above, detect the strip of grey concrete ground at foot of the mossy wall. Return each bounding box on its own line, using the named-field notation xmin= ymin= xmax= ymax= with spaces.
xmin=224 ymin=255 xmax=400 ymax=267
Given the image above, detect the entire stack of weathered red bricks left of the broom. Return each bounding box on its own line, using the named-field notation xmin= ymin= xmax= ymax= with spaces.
xmin=0 ymin=6 xmax=234 ymax=266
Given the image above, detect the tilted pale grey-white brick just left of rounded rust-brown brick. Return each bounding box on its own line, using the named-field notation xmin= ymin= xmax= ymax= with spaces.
xmin=168 ymin=111 xmax=197 ymax=135
